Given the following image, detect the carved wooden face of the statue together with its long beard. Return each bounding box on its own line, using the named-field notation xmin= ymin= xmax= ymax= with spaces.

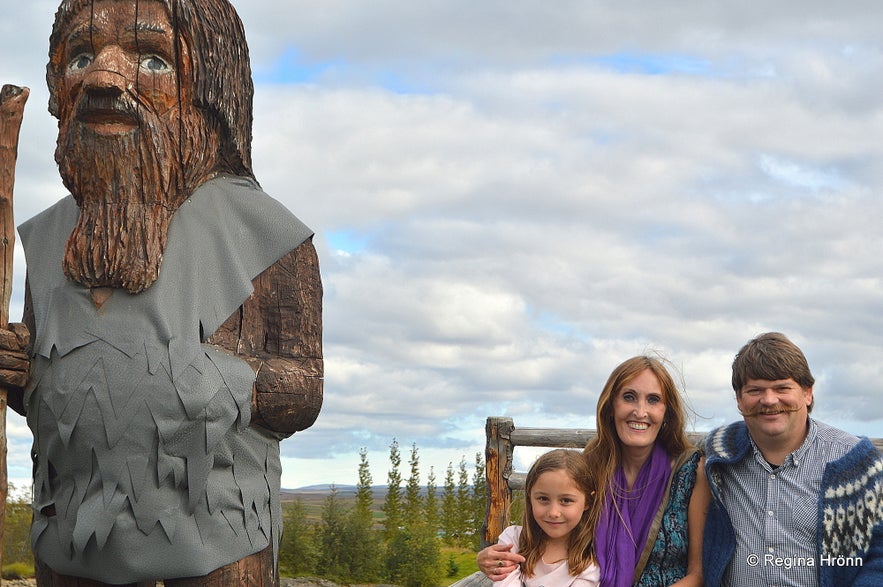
xmin=54 ymin=0 xmax=220 ymax=293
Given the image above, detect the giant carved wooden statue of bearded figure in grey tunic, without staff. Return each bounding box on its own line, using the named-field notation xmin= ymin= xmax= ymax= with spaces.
xmin=0 ymin=0 xmax=322 ymax=586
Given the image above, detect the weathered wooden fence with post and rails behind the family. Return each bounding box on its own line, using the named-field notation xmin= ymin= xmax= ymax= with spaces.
xmin=482 ymin=417 xmax=883 ymax=546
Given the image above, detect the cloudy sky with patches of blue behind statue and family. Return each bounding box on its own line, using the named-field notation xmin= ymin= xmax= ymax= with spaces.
xmin=0 ymin=0 xmax=883 ymax=487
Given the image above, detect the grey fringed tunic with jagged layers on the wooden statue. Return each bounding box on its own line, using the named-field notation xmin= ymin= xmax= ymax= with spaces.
xmin=19 ymin=177 xmax=311 ymax=583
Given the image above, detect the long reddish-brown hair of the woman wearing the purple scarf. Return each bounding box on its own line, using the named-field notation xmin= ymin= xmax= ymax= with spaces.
xmin=583 ymin=355 xmax=692 ymax=527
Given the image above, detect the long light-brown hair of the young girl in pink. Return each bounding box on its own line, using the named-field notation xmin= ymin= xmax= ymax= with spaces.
xmin=518 ymin=449 xmax=597 ymax=577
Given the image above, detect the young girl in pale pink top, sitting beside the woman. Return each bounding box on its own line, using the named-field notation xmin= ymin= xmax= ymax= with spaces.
xmin=494 ymin=449 xmax=600 ymax=587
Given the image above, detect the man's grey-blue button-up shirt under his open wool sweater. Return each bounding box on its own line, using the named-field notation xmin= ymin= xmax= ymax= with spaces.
xmin=721 ymin=419 xmax=845 ymax=587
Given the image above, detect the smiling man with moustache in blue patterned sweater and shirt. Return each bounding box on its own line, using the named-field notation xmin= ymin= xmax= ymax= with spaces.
xmin=703 ymin=333 xmax=883 ymax=587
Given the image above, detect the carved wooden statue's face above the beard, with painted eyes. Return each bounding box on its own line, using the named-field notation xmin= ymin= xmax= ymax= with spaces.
xmin=59 ymin=0 xmax=191 ymax=134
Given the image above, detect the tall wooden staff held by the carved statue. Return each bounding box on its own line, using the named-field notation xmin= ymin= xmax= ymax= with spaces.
xmin=0 ymin=84 xmax=30 ymax=576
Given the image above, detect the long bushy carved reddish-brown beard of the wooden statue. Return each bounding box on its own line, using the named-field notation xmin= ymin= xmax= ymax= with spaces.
xmin=56 ymin=100 xmax=217 ymax=293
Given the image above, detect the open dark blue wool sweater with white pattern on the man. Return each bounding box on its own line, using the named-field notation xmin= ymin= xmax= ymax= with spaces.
xmin=702 ymin=422 xmax=883 ymax=587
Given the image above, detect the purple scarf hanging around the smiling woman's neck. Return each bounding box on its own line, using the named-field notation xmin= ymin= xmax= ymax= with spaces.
xmin=595 ymin=443 xmax=671 ymax=587
